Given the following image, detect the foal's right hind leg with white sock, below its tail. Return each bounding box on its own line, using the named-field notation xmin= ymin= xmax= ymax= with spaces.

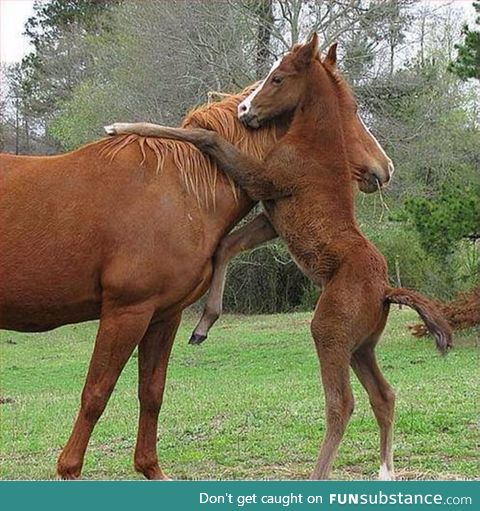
xmin=351 ymin=334 xmax=395 ymax=480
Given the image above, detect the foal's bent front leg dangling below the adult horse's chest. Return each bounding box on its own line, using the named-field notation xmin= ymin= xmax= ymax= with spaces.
xmin=189 ymin=213 xmax=278 ymax=344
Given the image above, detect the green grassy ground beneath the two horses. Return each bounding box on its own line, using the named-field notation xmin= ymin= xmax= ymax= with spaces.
xmin=0 ymin=311 xmax=480 ymax=479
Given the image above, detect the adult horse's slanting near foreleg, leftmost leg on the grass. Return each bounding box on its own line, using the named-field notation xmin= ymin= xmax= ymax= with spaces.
xmin=57 ymin=304 xmax=153 ymax=479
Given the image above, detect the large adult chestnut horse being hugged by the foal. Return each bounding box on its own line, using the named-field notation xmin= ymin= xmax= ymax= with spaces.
xmin=0 ymin=57 xmax=390 ymax=479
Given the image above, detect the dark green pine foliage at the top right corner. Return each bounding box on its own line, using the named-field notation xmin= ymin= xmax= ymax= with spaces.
xmin=449 ymin=2 xmax=480 ymax=80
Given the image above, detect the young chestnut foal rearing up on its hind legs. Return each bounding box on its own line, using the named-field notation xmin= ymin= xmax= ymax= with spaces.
xmin=109 ymin=35 xmax=451 ymax=479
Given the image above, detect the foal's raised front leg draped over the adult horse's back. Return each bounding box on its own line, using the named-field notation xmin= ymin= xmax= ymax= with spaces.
xmin=105 ymin=122 xmax=292 ymax=200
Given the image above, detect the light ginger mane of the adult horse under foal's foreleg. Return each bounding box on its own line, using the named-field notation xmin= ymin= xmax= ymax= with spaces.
xmin=98 ymin=87 xmax=277 ymax=208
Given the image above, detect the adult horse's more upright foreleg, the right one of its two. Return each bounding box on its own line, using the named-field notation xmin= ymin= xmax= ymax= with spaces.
xmin=134 ymin=314 xmax=181 ymax=479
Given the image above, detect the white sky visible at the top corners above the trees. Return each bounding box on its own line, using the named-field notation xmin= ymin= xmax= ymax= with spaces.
xmin=0 ymin=0 xmax=473 ymax=64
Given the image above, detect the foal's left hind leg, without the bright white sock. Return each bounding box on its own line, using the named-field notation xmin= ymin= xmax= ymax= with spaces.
xmin=311 ymin=304 xmax=354 ymax=479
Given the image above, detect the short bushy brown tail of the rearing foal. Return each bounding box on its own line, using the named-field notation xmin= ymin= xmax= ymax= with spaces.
xmin=385 ymin=287 xmax=452 ymax=353
